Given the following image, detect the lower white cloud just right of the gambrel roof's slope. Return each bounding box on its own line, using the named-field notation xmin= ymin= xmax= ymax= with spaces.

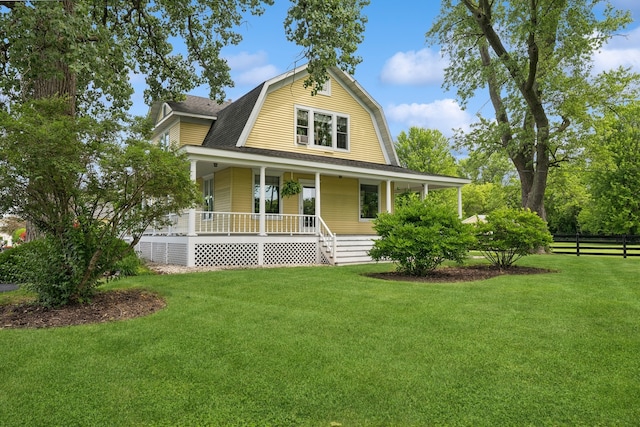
xmin=385 ymin=99 xmax=472 ymax=137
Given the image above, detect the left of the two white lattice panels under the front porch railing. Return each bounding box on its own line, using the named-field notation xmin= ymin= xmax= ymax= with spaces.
xmin=195 ymin=243 xmax=258 ymax=266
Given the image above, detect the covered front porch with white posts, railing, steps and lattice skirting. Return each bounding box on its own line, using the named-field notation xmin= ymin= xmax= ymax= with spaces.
xmin=138 ymin=146 xmax=468 ymax=266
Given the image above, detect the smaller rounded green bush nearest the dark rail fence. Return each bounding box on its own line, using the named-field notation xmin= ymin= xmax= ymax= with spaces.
xmin=476 ymin=208 xmax=553 ymax=268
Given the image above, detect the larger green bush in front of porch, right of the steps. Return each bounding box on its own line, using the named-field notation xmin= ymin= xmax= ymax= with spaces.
xmin=369 ymin=197 xmax=475 ymax=276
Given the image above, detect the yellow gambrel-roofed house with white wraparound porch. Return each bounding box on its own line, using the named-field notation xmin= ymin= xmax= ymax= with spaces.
xmin=138 ymin=66 xmax=469 ymax=266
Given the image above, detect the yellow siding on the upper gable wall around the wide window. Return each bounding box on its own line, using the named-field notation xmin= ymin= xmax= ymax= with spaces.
xmin=246 ymin=79 xmax=385 ymax=164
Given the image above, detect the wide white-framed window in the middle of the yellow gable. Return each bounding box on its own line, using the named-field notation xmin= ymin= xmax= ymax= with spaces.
xmin=296 ymin=107 xmax=349 ymax=150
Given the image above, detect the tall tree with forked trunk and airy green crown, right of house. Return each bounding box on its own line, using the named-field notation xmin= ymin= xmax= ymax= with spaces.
xmin=427 ymin=0 xmax=637 ymax=218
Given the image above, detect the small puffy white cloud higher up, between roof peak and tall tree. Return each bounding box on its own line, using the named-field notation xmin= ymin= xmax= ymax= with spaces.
xmin=380 ymin=49 xmax=447 ymax=85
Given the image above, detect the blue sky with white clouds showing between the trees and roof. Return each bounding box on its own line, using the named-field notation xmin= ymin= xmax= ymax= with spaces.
xmin=132 ymin=0 xmax=640 ymax=140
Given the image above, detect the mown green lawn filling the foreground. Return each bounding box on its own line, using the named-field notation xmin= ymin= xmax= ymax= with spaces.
xmin=0 ymin=255 xmax=640 ymax=426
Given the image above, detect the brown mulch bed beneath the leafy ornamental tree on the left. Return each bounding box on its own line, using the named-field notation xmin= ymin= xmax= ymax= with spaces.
xmin=0 ymin=289 xmax=166 ymax=329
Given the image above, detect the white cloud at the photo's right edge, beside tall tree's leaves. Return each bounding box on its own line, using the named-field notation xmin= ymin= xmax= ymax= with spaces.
xmin=593 ymin=28 xmax=640 ymax=72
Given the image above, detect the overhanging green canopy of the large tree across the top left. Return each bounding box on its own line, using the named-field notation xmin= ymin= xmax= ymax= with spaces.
xmin=0 ymin=0 xmax=368 ymax=115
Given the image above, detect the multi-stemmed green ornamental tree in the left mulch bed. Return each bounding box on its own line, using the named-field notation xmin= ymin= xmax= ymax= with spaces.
xmin=0 ymin=98 xmax=199 ymax=305
